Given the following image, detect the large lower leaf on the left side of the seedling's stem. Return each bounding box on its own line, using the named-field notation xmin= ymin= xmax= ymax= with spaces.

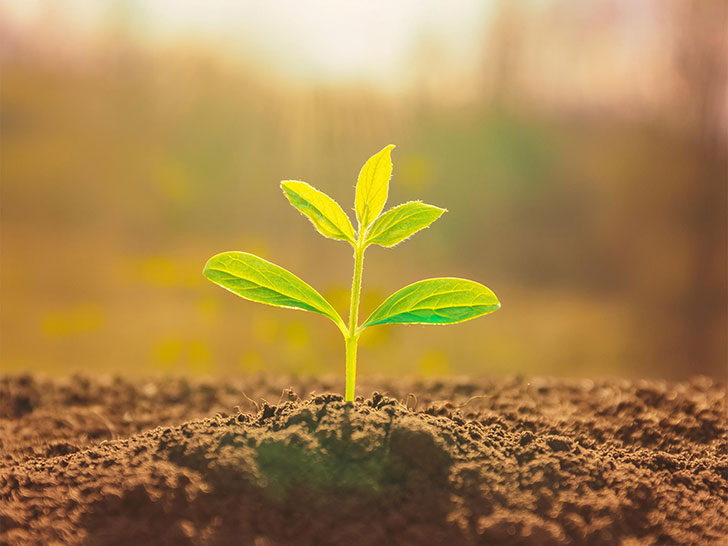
xmin=202 ymin=252 xmax=346 ymax=331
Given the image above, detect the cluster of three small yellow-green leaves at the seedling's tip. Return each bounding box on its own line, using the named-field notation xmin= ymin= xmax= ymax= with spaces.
xmin=281 ymin=144 xmax=445 ymax=247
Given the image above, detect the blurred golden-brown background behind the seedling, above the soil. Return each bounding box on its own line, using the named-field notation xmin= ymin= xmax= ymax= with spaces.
xmin=0 ymin=0 xmax=728 ymax=378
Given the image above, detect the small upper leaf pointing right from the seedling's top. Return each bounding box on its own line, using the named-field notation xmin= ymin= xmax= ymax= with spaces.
xmin=366 ymin=201 xmax=446 ymax=247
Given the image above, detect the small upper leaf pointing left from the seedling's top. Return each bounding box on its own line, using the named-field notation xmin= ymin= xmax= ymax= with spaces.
xmin=281 ymin=180 xmax=356 ymax=244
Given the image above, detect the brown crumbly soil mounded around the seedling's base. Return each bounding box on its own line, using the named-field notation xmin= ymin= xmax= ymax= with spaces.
xmin=0 ymin=375 xmax=728 ymax=546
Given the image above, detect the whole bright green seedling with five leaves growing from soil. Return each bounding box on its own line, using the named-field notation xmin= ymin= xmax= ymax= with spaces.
xmin=203 ymin=144 xmax=500 ymax=401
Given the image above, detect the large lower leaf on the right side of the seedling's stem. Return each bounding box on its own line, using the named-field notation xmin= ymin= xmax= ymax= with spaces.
xmin=361 ymin=278 xmax=500 ymax=329
